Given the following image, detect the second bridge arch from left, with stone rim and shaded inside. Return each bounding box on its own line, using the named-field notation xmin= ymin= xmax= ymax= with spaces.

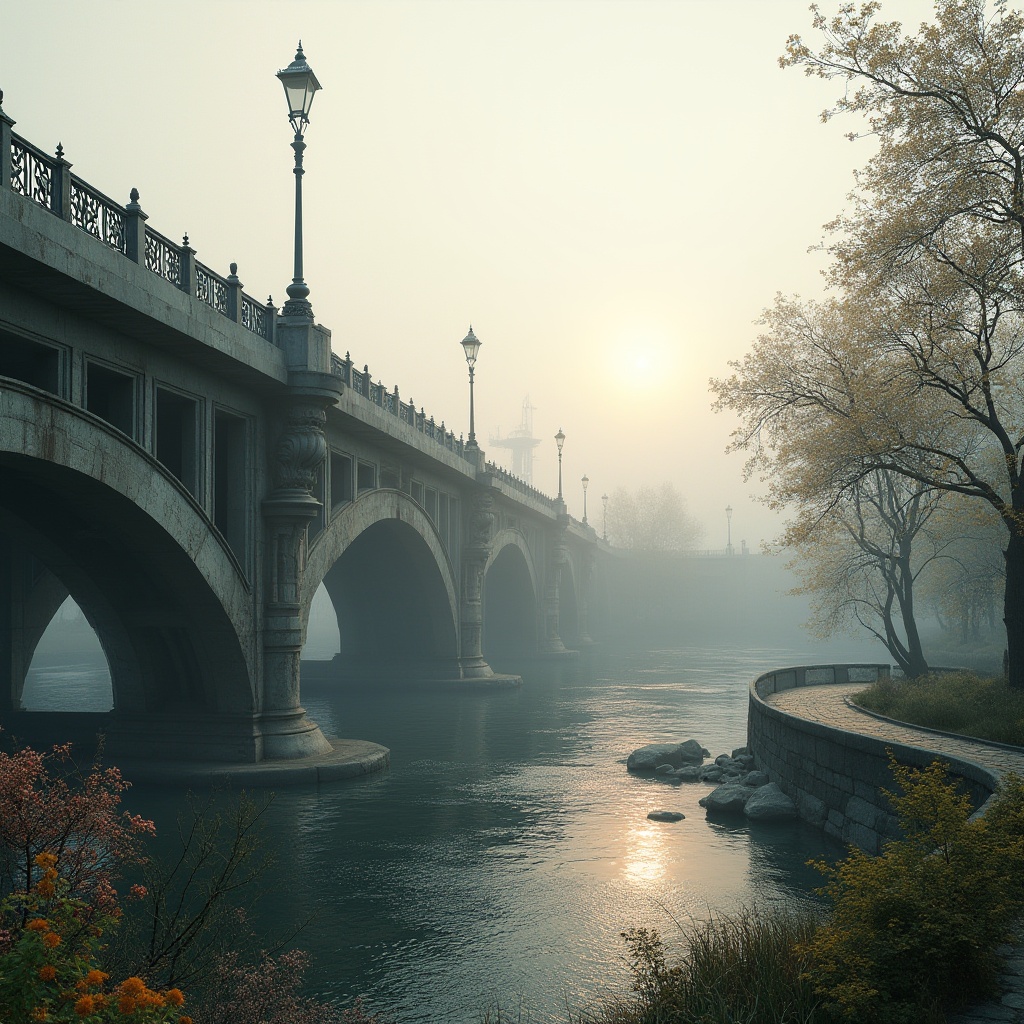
xmin=299 ymin=488 xmax=459 ymax=676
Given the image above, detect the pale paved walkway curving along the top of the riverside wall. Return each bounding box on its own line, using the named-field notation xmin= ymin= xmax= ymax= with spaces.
xmin=765 ymin=683 xmax=1024 ymax=1024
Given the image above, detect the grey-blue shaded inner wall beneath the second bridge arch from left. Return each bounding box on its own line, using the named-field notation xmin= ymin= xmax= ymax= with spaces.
xmin=324 ymin=519 xmax=459 ymax=680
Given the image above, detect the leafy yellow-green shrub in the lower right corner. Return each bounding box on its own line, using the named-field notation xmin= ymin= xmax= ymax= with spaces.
xmin=806 ymin=762 xmax=1024 ymax=1024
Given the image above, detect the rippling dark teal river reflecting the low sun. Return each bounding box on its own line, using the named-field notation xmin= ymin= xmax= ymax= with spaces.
xmin=27 ymin=643 xmax=873 ymax=1024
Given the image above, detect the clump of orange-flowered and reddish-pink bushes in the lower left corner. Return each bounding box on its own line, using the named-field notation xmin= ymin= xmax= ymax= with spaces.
xmin=0 ymin=744 xmax=382 ymax=1024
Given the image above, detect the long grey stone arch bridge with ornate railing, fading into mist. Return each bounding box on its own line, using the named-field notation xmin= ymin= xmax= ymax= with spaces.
xmin=0 ymin=99 xmax=603 ymax=763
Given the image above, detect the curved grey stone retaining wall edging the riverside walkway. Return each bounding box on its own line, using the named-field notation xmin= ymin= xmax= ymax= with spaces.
xmin=746 ymin=665 xmax=996 ymax=853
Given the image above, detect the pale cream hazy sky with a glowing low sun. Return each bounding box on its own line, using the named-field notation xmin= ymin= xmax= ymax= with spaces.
xmin=0 ymin=0 xmax=932 ymax=547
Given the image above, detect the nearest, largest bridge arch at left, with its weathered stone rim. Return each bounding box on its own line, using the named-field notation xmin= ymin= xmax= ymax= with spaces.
xmin=0 ymin=381 xmax=258 ymax=714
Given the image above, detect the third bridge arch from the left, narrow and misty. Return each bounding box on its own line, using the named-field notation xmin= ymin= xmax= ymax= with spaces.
xmin=483 ymin=529 xmax=541 ymax=657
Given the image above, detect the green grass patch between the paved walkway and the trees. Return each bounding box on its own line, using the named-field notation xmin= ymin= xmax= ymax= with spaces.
xmin=854 ymin=672 xmax=1024 ymax=746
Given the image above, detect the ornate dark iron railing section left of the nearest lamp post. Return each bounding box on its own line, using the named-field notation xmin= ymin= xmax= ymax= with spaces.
xmin=0 ymin=117 xmax=278 ymax=343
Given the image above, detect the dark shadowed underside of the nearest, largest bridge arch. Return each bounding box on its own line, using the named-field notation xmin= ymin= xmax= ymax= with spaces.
xmin=0 ymin=452 xmax=259 ymax=761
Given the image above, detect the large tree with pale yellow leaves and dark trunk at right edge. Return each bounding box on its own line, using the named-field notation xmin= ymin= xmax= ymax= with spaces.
xmin=713 ymin=0 xmax=1024 ymax=688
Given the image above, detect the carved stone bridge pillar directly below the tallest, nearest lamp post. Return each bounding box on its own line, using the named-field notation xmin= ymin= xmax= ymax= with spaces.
xmin=259 ymin=317 xmax=342 ymax=759
